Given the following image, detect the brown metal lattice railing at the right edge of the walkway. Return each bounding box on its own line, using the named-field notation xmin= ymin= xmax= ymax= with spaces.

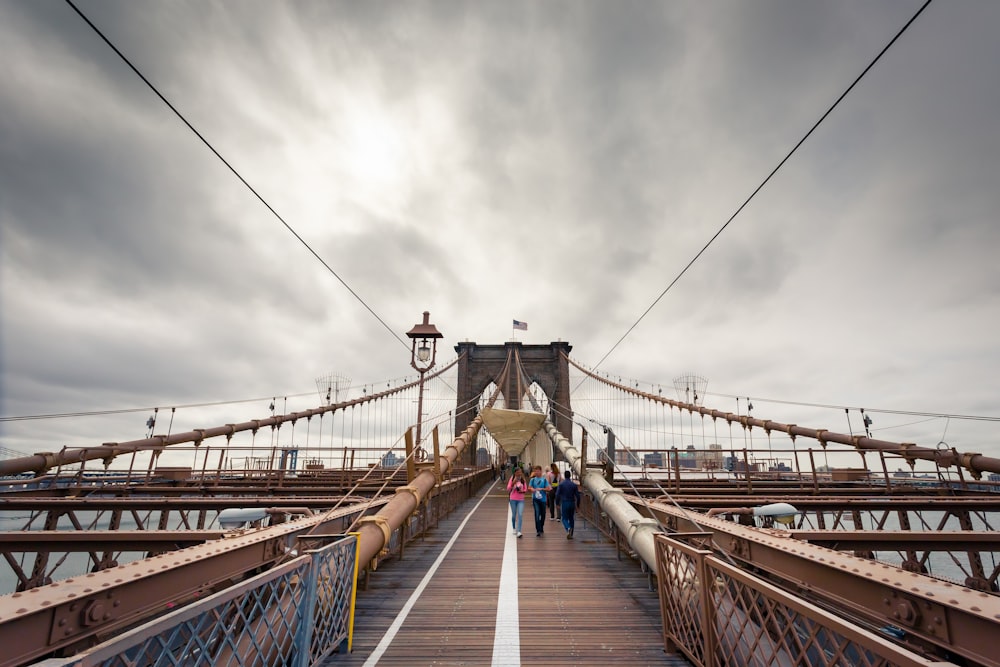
xmin=655 ymin=533 xmax=941 ymax=667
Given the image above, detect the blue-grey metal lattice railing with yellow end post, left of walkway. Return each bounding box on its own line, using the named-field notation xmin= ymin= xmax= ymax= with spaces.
xmin=42 ymin=535 xmax=357 ymax=667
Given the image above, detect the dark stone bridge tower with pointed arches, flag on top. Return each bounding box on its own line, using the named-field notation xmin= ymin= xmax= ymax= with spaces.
xmin=455 ymin=341 xmax=573 ymax=463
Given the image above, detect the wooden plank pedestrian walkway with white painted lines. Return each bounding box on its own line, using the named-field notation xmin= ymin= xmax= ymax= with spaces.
xmin=324 ymin=480 xmax=690 ymax=667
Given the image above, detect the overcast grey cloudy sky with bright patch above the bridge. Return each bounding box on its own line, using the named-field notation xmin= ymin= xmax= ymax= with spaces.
xmin=0 ymin=0 xmax=1000 ymax=456
